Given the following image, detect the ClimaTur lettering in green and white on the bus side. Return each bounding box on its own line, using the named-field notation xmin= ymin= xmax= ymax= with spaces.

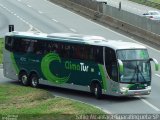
xmin=65 ymin=61 xmax=89 ymax=72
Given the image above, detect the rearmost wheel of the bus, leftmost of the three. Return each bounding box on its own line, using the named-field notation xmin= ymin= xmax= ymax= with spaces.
xmin=19 ymin=72 xmax=29 ymax=86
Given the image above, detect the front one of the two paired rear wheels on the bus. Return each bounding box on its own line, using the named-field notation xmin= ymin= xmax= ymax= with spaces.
xmin=30 ymin=74 xmax=39 ymax=88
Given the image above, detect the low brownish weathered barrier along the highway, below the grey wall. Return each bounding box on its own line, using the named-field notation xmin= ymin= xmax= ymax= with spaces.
xmin=50 ymin=0 xmax=160 ymax=45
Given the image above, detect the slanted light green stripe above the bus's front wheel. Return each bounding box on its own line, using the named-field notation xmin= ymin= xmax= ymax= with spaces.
xmin=98 ymin=64 xmax=107 ymax=90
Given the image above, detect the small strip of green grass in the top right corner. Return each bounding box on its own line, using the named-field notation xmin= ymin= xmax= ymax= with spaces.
xmin=130 ymin=0 xmax=160 ymax=9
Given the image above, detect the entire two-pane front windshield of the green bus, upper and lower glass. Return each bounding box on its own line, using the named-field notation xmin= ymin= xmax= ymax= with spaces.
xmin=117 ymin=49 xmax=151 ymax=83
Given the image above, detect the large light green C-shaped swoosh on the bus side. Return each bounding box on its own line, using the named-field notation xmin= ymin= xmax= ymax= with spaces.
xmin=41 ymin=53 xmax=70 ymax=84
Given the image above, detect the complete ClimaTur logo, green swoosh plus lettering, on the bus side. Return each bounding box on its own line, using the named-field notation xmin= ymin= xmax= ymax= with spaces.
xmin=41 ymin=53 xmax=90 ymax=84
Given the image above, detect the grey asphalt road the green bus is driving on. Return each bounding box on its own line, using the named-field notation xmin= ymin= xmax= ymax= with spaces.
xmin=0 ymin=0 xmax=160 ymax=113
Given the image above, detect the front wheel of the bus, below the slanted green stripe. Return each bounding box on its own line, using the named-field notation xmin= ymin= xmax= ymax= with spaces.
xmin=94 ymin=83 xmax=102 ymax=99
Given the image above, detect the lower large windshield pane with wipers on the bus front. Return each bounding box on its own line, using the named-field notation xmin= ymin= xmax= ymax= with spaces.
xmin=120 ymin=60 xmax=151 ymax=83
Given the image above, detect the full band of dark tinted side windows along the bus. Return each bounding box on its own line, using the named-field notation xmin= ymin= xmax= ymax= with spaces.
xmin=6 ymin=37 xmax=103 ymax=64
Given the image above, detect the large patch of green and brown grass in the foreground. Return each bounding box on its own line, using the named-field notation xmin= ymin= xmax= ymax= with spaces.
xmin=0 ymin=84 xmax=104 ymax=120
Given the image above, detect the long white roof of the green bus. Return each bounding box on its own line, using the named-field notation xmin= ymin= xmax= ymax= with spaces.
xmin=6 ymin=31 xmax=146 ymax=50
